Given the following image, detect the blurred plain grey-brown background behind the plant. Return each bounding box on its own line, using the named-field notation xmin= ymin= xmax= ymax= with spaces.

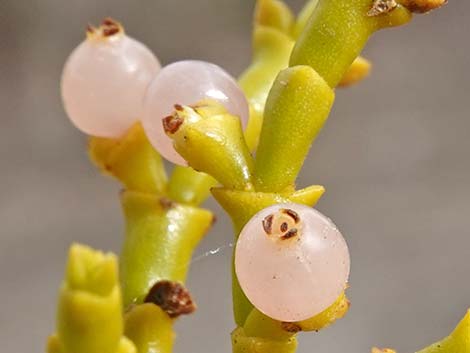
xmin=0 ymin=0 xmax=470 ymax=353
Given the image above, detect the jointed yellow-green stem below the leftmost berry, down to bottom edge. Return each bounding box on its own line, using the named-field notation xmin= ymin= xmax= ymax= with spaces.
xmin=87 ymin=124 xmax=215 ymax=353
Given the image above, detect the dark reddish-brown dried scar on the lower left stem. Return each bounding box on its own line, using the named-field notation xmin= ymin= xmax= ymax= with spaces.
xmin=144 ymin=281 xmax=196 ymax=319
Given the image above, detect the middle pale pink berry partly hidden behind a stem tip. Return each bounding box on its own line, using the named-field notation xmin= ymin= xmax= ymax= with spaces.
xmin=142 ymin=60 xmax=249 ymax=165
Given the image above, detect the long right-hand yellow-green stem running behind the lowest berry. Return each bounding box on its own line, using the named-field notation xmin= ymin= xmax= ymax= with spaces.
xmin=228 ymin=0 xmax=411 ymax=352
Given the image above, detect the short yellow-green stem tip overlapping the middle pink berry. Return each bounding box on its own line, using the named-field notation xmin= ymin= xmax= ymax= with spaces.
xmin=166 ymin=101 xmax=253 ymax=190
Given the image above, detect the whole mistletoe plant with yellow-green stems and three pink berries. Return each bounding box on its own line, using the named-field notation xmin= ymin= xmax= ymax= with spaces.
xmin=47 ymin=0 xmax=470 ymax=353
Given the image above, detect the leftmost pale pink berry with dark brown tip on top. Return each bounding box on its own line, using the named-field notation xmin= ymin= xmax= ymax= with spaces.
xmin=62 ymin=19 xmax=160 ymax=138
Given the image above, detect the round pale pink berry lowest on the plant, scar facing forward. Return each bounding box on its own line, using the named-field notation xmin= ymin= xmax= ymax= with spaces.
xmin=235 ymin=204 xmax=350 ymax=322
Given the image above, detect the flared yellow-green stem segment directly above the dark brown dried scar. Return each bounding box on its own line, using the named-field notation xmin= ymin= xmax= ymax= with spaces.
xmin=121 ymin=191 xmax=213 ymax=306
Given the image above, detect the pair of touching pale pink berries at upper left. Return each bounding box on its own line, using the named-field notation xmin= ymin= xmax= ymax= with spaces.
xmin=62 ymin=19 xmax=249 ymax=165
